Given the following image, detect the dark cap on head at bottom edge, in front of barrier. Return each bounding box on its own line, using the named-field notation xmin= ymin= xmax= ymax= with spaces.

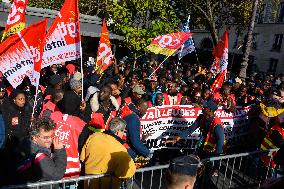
xmin=169 ymin=155 xmax=201 ymax=177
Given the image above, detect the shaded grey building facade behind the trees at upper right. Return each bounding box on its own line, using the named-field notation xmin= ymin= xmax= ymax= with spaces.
xmin=192 ymin=0 xmax=284 ymax=74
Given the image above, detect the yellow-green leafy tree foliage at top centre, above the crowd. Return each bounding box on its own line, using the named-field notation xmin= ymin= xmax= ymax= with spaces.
xmin=106 ymin=0 xmax=180 ymax=53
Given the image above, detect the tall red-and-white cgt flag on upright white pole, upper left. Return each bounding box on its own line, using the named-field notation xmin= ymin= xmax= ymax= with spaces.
xmin=42 ymin=0 xmax=81 ymax=67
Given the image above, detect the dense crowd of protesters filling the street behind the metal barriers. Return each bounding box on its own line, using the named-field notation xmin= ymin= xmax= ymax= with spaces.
xmin=0 ymin=55 xmax=284 ymax=188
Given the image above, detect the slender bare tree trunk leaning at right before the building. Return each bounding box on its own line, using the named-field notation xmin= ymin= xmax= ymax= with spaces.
xmin=239 ymin=0 xmax=258 ymax=79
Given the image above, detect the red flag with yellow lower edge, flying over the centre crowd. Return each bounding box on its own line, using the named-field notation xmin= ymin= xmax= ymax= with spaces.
xmin=147 ymin=32 xmax=191 ymax=56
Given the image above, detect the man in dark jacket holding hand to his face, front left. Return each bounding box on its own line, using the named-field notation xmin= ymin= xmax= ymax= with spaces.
xmin=13 ymin=117 xmax=67 ymax=184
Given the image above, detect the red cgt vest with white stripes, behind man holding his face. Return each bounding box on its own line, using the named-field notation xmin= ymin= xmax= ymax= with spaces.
xmin=50 ymin=111 xmax=86 ymax=177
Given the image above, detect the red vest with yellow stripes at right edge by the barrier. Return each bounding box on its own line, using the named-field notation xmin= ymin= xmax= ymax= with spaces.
xmin=260 ymin=125 xmax=284 ymax=168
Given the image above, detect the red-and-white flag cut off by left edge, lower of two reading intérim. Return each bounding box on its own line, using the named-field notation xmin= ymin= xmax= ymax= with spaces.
xmin=0 ymin=19 xmax=47 ymax=88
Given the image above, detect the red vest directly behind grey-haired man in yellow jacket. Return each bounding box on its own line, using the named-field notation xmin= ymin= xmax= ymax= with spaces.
xmin=89 ymin=111 xmax=117 ymax=132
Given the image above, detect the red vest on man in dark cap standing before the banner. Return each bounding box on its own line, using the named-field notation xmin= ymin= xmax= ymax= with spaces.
xmin=199 ymin=117 xmax=226 ymax=154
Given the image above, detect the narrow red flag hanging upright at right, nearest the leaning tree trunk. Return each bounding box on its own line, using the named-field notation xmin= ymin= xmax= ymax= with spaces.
xmin=212 ymin=31 xmax=229 ymax=72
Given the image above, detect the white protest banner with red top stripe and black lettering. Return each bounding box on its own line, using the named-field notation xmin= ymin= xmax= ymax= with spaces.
xmin=141 ymin=105 xmax=249 ymax=150
